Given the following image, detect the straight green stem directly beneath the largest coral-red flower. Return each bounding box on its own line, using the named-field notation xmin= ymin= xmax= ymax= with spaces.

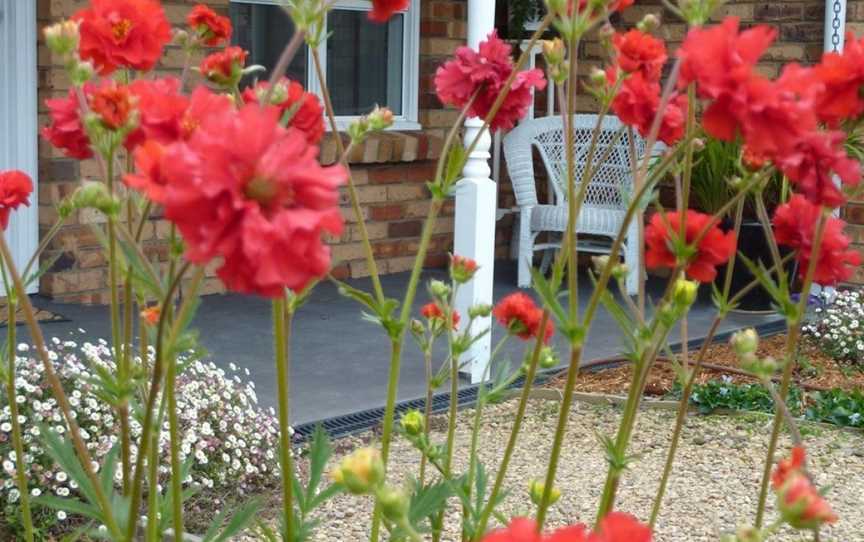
xmin=273 ymin=296 xmax=294 ymax=540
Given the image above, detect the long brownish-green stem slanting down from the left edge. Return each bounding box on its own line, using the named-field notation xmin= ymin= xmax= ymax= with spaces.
xmin=0 ymin=235 xmax=120 ymax=538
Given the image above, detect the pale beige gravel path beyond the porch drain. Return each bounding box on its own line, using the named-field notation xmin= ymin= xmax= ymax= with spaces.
xmin=306 ymin=400 xmax=864 ymax=542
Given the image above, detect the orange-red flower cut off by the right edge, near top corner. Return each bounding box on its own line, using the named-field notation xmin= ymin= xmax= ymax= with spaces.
xmin=814 ymin=33 xmax=864 ymax=127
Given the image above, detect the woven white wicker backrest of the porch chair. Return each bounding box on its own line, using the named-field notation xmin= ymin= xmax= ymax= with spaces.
xmin=504 ymin=114 xmax=645 ymax=209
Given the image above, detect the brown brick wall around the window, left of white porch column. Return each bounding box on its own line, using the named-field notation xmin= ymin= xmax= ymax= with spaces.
xmin=37 ymin=0 xmax=466 ymax=303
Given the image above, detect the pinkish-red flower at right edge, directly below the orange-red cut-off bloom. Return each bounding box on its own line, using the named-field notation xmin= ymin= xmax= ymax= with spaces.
xmin=776 ymin=131 xmax=861 ymax=207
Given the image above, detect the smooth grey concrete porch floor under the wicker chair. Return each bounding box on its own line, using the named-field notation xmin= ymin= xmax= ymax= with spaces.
xmin=20 ymin=261 xmax=777 ymax=424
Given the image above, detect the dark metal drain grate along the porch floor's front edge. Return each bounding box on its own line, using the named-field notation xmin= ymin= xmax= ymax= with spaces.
xmin=294 ymin=319 xmax=786 ymax=442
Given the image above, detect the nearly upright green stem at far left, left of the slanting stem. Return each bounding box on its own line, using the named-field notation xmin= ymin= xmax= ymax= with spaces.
xmin=0 ymin=294 xmax=33 ymax=542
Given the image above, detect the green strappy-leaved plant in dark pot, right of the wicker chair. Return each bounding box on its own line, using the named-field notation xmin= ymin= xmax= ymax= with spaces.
xmin=690 ymin=137 xmax=795 ymax=312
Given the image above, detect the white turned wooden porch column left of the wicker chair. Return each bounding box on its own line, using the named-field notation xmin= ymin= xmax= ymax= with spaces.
xmin=453 ymin=0 xmax=498 ymax=383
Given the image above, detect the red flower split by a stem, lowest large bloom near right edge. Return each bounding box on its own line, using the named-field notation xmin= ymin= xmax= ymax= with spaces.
xmin=774 ymin=198 xmax=861 ymax=285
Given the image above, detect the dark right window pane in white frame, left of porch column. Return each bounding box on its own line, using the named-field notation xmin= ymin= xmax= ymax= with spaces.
xmin=327 ymin=9 xmax=405 ymax=115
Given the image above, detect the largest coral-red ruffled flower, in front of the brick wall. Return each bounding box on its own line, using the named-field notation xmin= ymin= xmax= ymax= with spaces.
xmin=161 ymin=104 xmax=346 ymax=297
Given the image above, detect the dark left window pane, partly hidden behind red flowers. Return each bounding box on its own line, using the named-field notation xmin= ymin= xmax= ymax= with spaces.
xmin=231 ymin=3 xmax=307 ymax=86
